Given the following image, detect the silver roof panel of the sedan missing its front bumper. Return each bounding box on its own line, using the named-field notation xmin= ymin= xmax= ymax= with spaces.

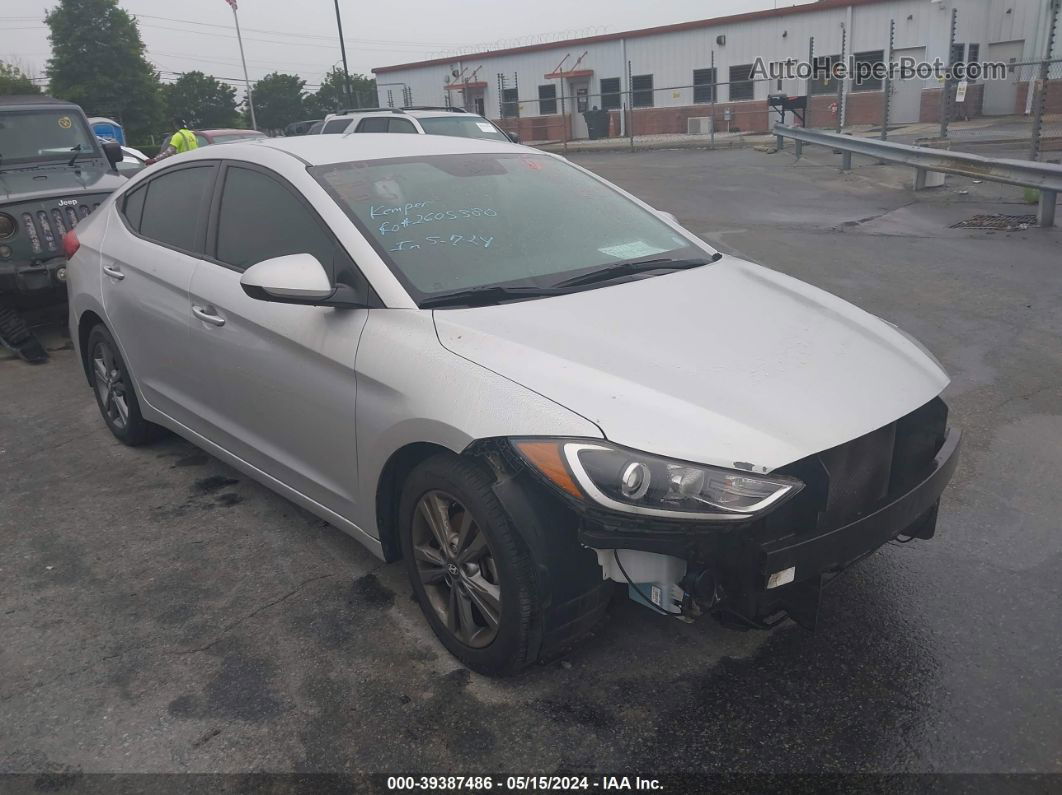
xmin=182 ymin=133 xmax=531 ymax=166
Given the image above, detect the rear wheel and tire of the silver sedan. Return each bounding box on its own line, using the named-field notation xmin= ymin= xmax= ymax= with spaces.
xmin=84 ymin=324 xmax=165 ymax=447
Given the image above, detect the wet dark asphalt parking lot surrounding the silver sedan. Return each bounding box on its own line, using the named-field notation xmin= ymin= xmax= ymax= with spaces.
xmin=0 ymin=144 xmax=1062 ymax=776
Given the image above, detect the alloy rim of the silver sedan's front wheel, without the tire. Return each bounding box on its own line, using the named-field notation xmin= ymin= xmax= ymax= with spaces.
xmin=413 ymin=491 xmax=501 ymax=649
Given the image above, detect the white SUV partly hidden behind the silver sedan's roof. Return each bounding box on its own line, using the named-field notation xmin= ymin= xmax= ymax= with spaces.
xmin=321 ymin=105 xmax=519 ymax=142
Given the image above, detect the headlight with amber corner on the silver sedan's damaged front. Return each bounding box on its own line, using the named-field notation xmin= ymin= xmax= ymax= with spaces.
xmin=513 ymin=438 xmax=804 ymax=521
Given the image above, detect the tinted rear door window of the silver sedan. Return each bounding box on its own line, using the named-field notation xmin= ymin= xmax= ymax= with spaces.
xmin=140 ymin=166 xmax=215 ymax=253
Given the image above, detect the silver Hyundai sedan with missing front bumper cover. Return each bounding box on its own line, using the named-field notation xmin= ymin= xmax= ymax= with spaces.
xmin=66 ymin=135 xmax=959 ymax=673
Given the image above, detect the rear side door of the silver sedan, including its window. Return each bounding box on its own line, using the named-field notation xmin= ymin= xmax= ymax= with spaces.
xmin=101 ymin=161 xmax=218 ymax=428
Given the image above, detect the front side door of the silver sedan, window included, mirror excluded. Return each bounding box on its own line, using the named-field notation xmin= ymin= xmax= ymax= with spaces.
xmin=190 ymin=163 xmax=370 ymax=516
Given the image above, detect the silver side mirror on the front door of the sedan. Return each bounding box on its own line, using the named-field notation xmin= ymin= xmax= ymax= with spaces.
xmin=240 ymin=254 xmax=365 ymax=309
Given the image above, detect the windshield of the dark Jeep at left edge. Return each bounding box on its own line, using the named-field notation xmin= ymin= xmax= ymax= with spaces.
xmin=0 ymin=110 xmax=100 ymax=165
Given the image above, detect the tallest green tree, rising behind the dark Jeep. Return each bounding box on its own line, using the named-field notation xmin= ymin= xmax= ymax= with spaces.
xmin=45 ymin=0 xmax=161 ymax=140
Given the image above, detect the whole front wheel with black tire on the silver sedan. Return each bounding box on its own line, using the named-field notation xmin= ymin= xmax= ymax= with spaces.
xmin=399 ymin=454 xmax=542 ymax=675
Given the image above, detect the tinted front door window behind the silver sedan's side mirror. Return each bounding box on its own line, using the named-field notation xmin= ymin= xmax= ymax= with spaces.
xmin=217 ymin=168 xmax=345 ymax=278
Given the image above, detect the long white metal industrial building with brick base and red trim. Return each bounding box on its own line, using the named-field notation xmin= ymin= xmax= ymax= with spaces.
xmin=373 ymin=0 xmax=1062 ymax=141
